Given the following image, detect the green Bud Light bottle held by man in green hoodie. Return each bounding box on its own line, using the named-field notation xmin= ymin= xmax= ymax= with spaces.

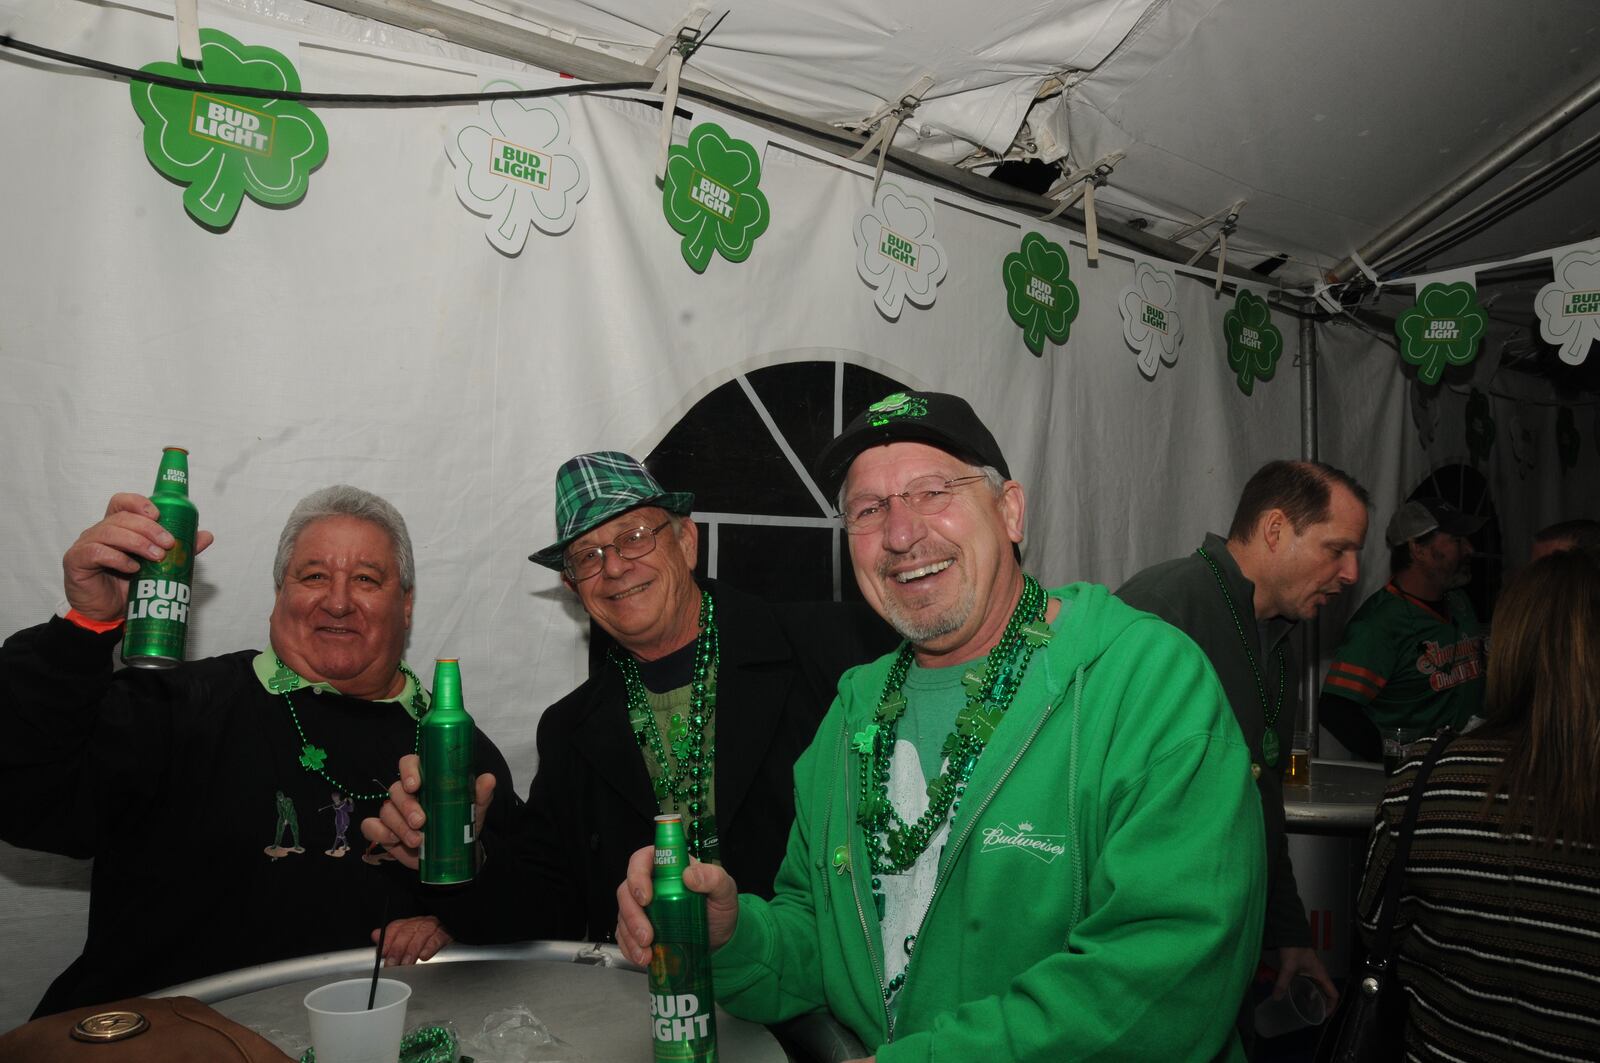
xmin=646 ymin=812 xmax=717 ymax=1063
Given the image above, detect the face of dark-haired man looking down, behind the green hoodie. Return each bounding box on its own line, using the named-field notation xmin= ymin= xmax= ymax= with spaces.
xmin=1258 ymin=483 xmax=1366 ymax=620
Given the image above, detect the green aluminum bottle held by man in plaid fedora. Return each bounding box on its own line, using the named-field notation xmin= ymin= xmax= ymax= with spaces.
xmin=418 ymin=658 xmax=478 ymax=885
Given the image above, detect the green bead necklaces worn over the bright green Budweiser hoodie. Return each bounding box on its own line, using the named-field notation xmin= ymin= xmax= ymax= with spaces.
xmin=851 ymin=573 xmax=1053 ymax=877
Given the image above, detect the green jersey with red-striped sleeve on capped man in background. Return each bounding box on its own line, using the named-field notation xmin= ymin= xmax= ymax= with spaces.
xmin=1322 ymin=583 xmax=1490 ymax=732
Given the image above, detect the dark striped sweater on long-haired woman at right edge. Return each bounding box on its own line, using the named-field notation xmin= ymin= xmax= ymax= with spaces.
xmin=1357 ymin=735 xmax=1600 ymax=1063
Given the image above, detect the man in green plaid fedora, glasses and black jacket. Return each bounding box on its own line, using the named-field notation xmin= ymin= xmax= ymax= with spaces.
xmin=363 ymin=451 xmax=893 ymax=959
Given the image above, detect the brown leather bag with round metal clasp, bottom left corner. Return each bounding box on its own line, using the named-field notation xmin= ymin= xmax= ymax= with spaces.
xmin=0 ymin=997 xmax=291 ymax=1063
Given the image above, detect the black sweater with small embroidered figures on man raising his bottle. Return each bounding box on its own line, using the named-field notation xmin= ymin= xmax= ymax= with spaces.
xmin=0 ymin=618 xmax=515 ymax=1015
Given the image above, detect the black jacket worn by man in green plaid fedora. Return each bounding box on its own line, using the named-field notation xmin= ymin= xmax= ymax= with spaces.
xmin=442 ymin=581 xmax=894 ymax=943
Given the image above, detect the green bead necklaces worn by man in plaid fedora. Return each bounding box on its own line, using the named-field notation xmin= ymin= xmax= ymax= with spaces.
xmin=611 ymin=591 xmax=722 ymax=860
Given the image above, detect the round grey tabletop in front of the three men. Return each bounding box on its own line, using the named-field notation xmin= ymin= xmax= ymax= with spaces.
xmin=196 ymin=945 xmax=786 ymax=1063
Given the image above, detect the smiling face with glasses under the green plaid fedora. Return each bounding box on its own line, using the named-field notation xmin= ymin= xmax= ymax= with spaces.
xmin=562 ymin=506 xmax=699 ymax=661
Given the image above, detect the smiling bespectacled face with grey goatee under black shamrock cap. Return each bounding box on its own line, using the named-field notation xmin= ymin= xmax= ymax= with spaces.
xmin=843 ymin=443 xmax=1024 ymax=666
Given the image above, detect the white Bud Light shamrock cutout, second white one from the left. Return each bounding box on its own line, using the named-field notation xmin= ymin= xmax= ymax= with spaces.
xmin=854 ymin=184 xmax=949 ymax=322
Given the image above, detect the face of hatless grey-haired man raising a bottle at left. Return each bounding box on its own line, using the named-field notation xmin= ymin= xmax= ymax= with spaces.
xmin=270 ymin=517 xmax=411 ymax=698
